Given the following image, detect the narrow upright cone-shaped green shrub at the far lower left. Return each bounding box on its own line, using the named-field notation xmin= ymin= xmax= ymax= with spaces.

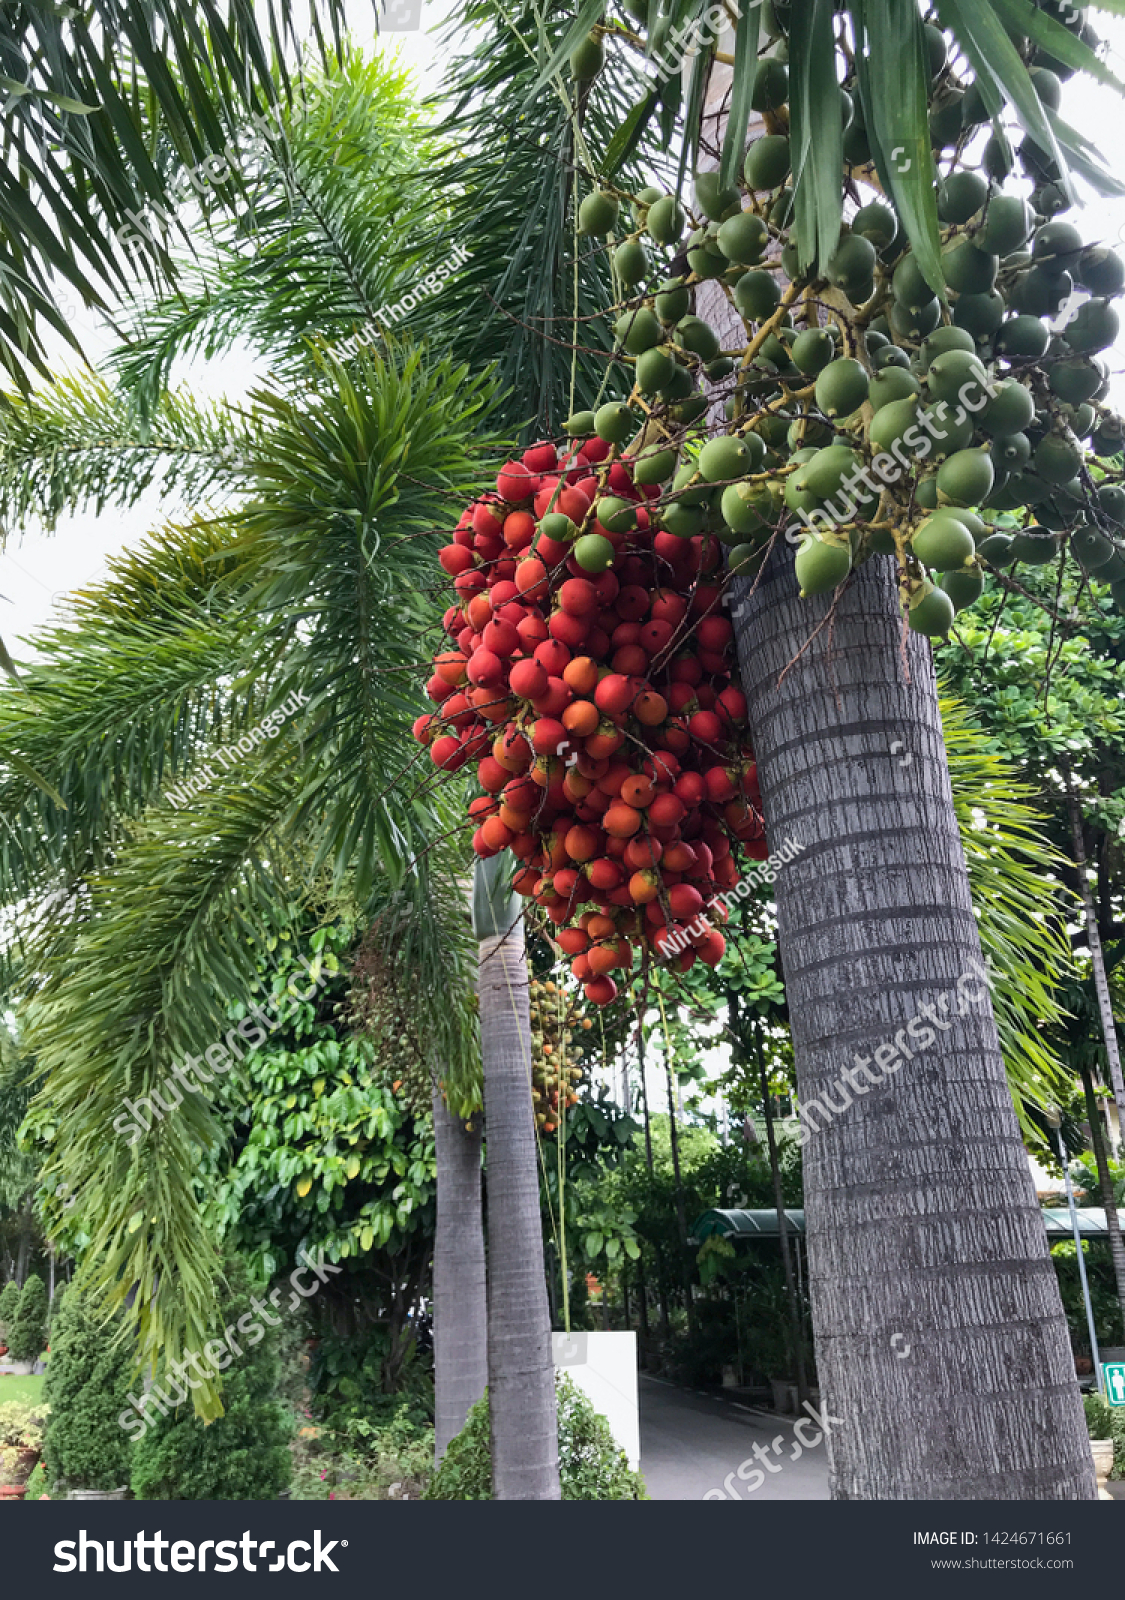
xmin=43 ymin=1285 xmax=133 ymax=1493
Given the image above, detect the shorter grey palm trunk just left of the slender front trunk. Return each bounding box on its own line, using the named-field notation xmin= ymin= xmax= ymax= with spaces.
xmin=434 ymin=1085 xmax=488 ymax=1462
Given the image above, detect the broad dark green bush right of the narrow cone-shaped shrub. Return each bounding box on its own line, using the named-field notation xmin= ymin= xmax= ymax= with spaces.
xmin=131 ymin=1264 xmax=291 ymax=1499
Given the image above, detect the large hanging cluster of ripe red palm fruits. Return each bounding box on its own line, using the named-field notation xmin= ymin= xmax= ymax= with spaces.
xmin=414 ymin=425 xmax=767 ymax=1005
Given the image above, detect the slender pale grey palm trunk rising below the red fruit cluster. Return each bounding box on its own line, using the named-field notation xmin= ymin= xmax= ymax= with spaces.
xmin=480 ymin=920 xmax=558 ymax=1499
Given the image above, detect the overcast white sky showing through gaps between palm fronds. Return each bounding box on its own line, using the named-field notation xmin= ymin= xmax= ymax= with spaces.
xmin=0 ymin=0 xmax=1125 ymax=658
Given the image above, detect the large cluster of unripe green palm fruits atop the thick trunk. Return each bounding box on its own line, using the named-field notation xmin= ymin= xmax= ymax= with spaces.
xmin=568 ymin=3 xmax=1125 ymax=637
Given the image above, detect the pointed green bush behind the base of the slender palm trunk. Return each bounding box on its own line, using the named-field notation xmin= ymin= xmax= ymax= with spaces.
xmin=422 ymin=1373 xmax=648 ymax=1499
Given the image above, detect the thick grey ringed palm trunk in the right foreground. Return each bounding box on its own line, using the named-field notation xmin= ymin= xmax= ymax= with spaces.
xmin=735 ymin=542 xmax=1095 ymax=1499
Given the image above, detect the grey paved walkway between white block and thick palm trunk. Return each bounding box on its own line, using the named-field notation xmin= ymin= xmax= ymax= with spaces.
xmin=640 ymin=1373 xmax=829 ymax=1501
